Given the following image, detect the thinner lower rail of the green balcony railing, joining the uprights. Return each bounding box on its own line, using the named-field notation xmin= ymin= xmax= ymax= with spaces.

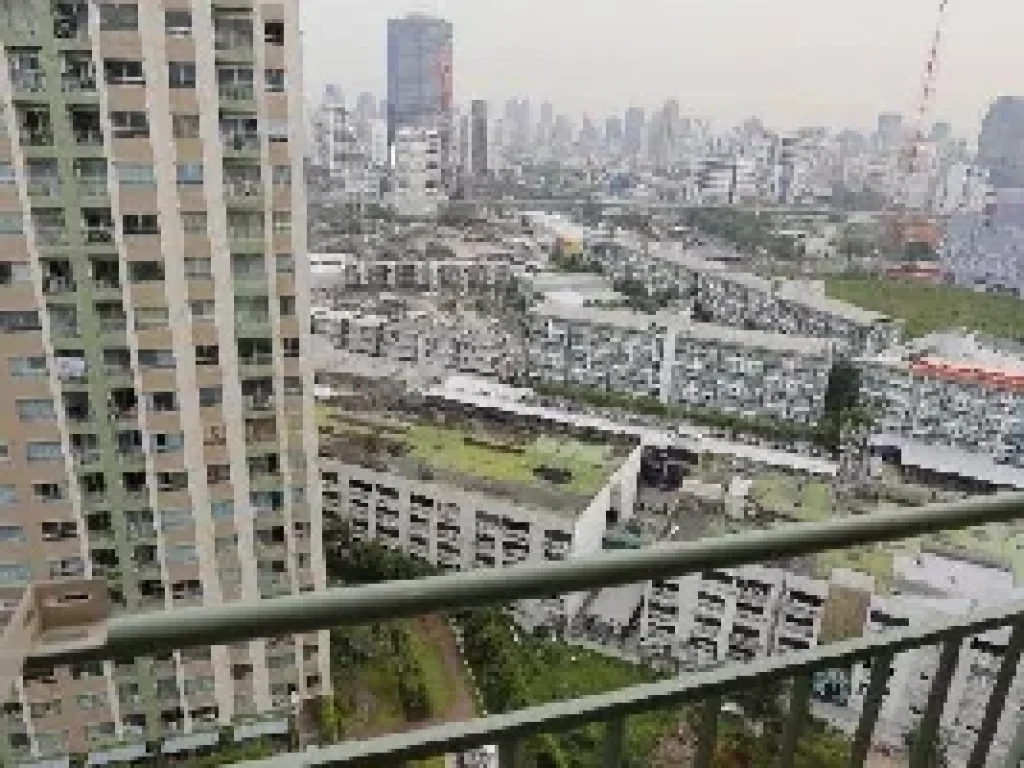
xmin=230 ymin=602 xmax=1024 ymax=768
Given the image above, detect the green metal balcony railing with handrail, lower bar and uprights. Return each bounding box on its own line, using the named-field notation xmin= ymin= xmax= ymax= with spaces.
xmin=16 ymin=494 xmax=1024 ymax=768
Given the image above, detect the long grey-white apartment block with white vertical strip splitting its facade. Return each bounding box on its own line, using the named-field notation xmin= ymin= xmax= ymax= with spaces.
xmin=526 ymin=303 xmax=833 ymax=424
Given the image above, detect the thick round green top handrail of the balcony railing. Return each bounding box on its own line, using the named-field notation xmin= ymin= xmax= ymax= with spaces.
xmin=28 ymin=493 xmax=1024 ymax=669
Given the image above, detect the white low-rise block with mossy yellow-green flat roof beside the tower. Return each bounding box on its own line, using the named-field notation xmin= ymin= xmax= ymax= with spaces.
xmin=321 ymin=412 xmax=641 ymax=615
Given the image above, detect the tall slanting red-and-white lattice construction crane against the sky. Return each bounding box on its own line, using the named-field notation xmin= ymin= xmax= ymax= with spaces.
xmin=892 ymin=0 xmax=949 ymax=256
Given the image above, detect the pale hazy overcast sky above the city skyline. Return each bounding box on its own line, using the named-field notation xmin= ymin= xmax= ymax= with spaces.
xmin=300 ymin=0 xmax=1024 ymax=138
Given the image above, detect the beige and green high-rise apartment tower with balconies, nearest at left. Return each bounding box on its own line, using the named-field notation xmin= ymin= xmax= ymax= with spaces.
xmin=0 ymin=0 xmax=330 ymax=765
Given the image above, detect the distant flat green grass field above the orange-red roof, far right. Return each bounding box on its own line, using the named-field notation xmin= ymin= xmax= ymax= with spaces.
xmin=825 ymin=278 xmax=1024 ymax=339
